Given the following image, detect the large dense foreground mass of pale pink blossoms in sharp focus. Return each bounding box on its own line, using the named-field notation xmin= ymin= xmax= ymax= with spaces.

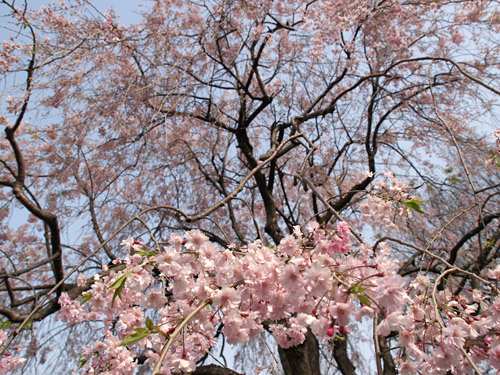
xmin=59 ymin=222 xmax=500 ymax=375
